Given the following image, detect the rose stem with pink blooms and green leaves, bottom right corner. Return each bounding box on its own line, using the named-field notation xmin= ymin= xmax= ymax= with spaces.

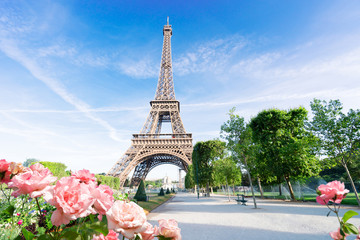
xmin=316 ymin=181 xmax=360 ymax=240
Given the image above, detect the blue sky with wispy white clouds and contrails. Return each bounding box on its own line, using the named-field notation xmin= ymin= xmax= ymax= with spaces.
xmin=0 ymin=0 xmax=360 ymax=178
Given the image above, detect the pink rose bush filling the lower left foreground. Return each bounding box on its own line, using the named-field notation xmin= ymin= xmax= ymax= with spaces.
xmin=0 ymin=159 xmax=181 ymax=240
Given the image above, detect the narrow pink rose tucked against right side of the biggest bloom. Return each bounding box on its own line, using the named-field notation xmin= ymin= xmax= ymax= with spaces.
xmin=92 ymin=185 xmax=114 ymax=215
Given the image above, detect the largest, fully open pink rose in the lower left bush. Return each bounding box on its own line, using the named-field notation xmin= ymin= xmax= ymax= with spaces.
xmin=44 ymin=177 xmax=96 ymax=226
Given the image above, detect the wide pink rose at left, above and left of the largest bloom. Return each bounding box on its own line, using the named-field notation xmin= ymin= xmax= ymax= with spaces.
xmin=9 ymin=163 xmax=57 ymax=198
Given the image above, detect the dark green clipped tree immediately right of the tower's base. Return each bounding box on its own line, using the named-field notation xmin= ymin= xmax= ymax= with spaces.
xmin=192 ymin=140 xmax=225 ymax=196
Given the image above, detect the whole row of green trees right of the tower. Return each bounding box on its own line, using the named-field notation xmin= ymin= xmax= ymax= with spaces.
xmin=185 ymin=99 xmax=360 ymax=205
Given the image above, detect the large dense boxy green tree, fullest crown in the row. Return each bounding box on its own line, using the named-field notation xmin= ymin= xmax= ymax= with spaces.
xmin=250 ymin=107 xmax=320 ymax=201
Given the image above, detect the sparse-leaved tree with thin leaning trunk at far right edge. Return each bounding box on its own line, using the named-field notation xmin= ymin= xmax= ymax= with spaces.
xmin=309 ymin=99 xmax=360 ymax=206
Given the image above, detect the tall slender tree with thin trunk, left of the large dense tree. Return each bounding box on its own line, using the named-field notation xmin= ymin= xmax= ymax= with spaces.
xmin=221 ymin=108 xmax=261 ymax=208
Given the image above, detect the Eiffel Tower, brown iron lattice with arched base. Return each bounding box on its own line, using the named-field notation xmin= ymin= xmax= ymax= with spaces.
xmin=108 ymin=18 xmax=193 ymax=187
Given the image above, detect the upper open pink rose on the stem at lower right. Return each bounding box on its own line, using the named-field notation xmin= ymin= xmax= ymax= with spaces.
xmin=316 ymin=181 xmax=349 ymax=205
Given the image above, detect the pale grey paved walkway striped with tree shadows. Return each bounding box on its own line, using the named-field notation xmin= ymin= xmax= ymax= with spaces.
xmin=148 ymin=193 xmax=360 ymax=240
